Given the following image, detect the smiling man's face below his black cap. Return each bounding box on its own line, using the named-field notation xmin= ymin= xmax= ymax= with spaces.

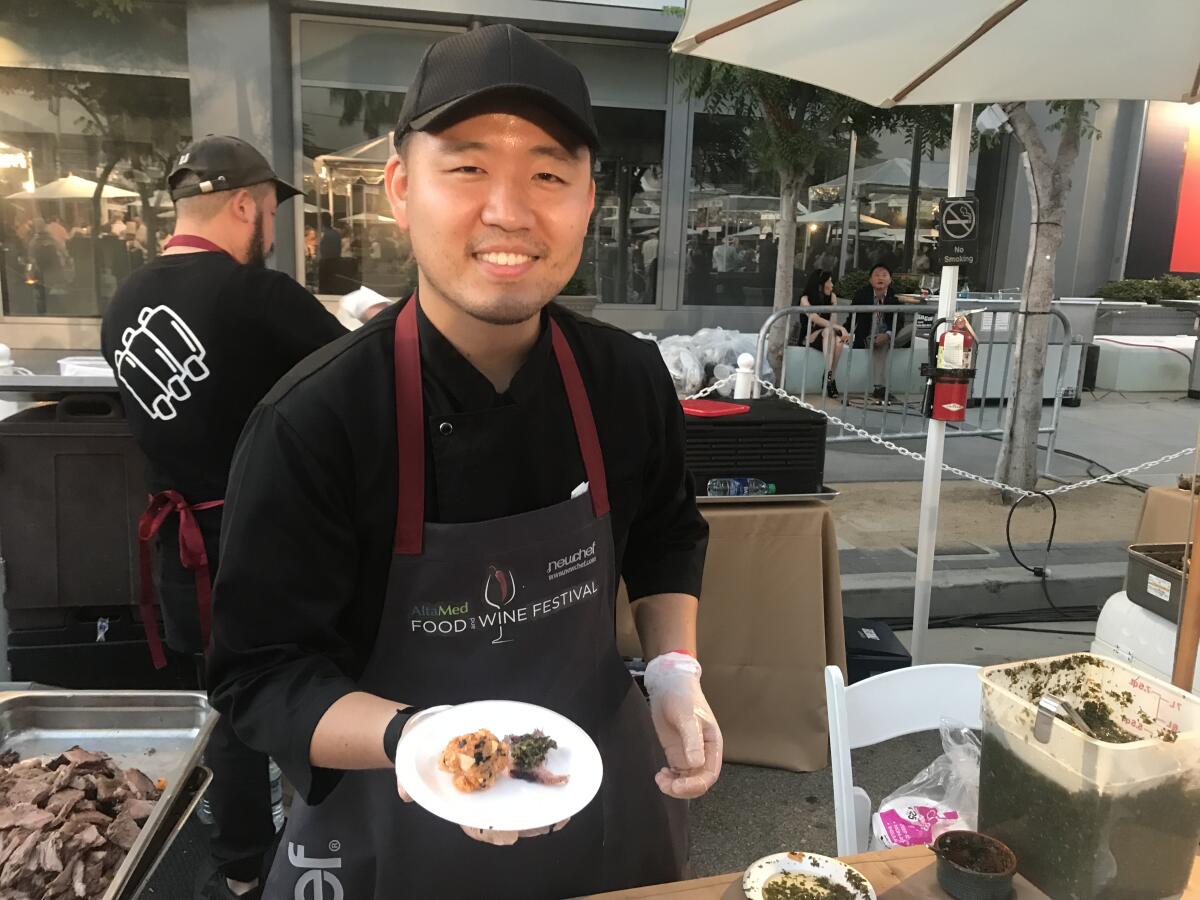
xmin=386 ymin=97 xmax=595 ymax=325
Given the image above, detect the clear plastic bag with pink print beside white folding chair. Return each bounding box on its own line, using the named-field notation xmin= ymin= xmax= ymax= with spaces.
xmin=871 ymin=719 xmax=979 ymax=850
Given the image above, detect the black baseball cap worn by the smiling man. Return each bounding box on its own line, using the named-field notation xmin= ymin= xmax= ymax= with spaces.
xmin=395 ymin=25 xmax=600 ymax=152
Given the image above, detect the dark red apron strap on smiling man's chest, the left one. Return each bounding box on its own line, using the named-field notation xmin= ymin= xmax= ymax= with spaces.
xmin=392 ymin=301 xmax=425 ymax=556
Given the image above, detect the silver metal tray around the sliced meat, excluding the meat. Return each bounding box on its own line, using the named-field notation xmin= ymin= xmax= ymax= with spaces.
xmin=0 ymin=690 xmax=217 ymax=900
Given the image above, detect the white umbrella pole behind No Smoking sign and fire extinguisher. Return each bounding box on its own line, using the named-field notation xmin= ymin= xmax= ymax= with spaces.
xmin=912 ymin=103 xmax=974 ymax=666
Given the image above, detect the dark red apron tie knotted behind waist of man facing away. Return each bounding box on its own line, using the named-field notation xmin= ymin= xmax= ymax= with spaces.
xmin=138 ymin=491 xmax=224 ymax=668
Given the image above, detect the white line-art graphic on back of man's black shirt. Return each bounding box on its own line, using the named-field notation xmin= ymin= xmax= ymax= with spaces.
xmin=114 ymin=306 xmax=210 ymax=421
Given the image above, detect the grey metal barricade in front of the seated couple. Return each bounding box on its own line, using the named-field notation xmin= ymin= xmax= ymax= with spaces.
xmin=755 ymin=298 xmax=1084 ymax=476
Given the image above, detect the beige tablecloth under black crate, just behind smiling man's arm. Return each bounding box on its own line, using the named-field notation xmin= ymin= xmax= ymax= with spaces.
xmin=618 ymin=502 xmax=846 ymax=772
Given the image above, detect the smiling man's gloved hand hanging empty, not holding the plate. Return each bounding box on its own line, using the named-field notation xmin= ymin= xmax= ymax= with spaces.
xmin=646 ymin=653 xmax=725 ymax=800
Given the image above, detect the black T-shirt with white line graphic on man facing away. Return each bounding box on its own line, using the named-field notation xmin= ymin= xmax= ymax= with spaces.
xmin=101 ymin=252 xmax=346 ymax=503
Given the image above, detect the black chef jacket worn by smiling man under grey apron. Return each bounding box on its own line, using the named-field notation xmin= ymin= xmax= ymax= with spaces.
xmin=209 ymin=304 xmax=708 ymax=803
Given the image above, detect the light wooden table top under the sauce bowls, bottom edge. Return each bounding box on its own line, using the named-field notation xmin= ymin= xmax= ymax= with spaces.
xmin=580 ymin=847 xmax=1200 ymax=900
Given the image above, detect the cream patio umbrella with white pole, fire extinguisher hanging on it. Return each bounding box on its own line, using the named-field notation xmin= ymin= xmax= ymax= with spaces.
xmin=673 ymin=0 xmax=1200 ymax=664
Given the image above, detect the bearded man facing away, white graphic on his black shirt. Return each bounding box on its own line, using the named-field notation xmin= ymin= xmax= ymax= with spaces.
xmin=101 ymin=134 xmax=346 ymax=900
